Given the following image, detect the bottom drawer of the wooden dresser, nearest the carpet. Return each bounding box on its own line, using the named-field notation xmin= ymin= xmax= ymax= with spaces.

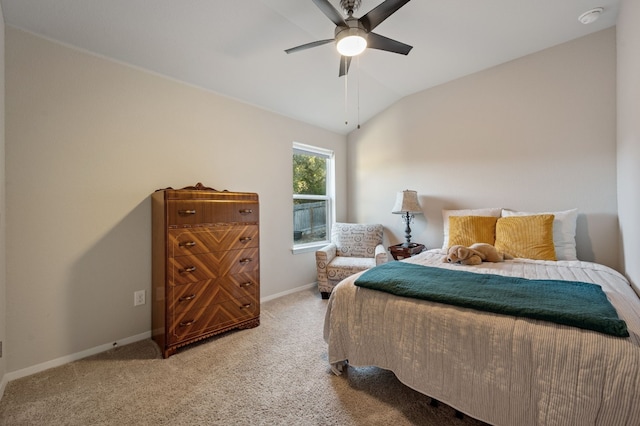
xmin=169 ymin=298 xmax=260 ymax=344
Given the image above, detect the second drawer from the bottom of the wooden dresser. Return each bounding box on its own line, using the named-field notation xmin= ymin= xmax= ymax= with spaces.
xmin=167 ymin=271 xmax=260 ymax=313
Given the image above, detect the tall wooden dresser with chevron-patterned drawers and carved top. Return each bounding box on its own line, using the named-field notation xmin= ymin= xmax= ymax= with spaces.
xmin=151 ymin=183 xmax=260 ymax=358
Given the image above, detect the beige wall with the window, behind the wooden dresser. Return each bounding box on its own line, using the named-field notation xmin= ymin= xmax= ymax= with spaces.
xmin=6 ymin=27 xmax=346 ymax=372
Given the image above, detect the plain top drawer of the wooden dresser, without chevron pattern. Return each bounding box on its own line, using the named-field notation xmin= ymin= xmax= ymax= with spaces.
xmin=167 ymin=200 xmax=259 ymax=227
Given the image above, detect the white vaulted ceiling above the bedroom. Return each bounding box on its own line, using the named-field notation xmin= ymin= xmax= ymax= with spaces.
xmin=0 ymin=0 xmax=619 ymax=134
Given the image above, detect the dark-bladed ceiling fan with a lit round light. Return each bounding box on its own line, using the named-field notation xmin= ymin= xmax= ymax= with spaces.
xmin=285 ymin=0 xmax=413 ymax=77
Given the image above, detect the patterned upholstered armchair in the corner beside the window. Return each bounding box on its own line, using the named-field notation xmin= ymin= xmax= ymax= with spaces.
xmin=316 ymin=223 xmax=388 ymax=299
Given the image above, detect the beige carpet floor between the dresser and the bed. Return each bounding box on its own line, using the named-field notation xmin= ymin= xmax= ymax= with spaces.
xmin=0 ymin=290 xmax=490 ymax=426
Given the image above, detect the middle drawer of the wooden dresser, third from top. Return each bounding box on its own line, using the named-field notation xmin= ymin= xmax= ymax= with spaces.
xmin=167 ymin=247 xmax=260 ymax=285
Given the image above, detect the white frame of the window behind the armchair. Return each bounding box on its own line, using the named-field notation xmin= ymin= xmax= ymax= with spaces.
xmin=290 ymin=142 xmax=336 ymax=254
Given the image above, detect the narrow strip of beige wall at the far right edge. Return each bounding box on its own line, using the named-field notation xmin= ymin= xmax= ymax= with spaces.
xmin=617 ymin=0 xmax=640 ymax=294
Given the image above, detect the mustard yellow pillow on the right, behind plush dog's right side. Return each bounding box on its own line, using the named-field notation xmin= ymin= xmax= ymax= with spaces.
xmin=495 ymin=214 xmax=556 ymax=260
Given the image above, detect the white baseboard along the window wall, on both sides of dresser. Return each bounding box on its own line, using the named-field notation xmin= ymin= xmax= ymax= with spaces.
xmin=0 ymin=282 xmax=317 ymax=390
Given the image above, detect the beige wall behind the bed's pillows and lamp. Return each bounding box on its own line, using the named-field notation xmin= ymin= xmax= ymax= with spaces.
xmin=348 ymin=28 xmax=619 ymax=267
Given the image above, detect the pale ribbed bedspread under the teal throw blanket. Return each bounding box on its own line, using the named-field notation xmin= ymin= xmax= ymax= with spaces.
xmin=324 ymin=250 xmax=640 ymax=426
